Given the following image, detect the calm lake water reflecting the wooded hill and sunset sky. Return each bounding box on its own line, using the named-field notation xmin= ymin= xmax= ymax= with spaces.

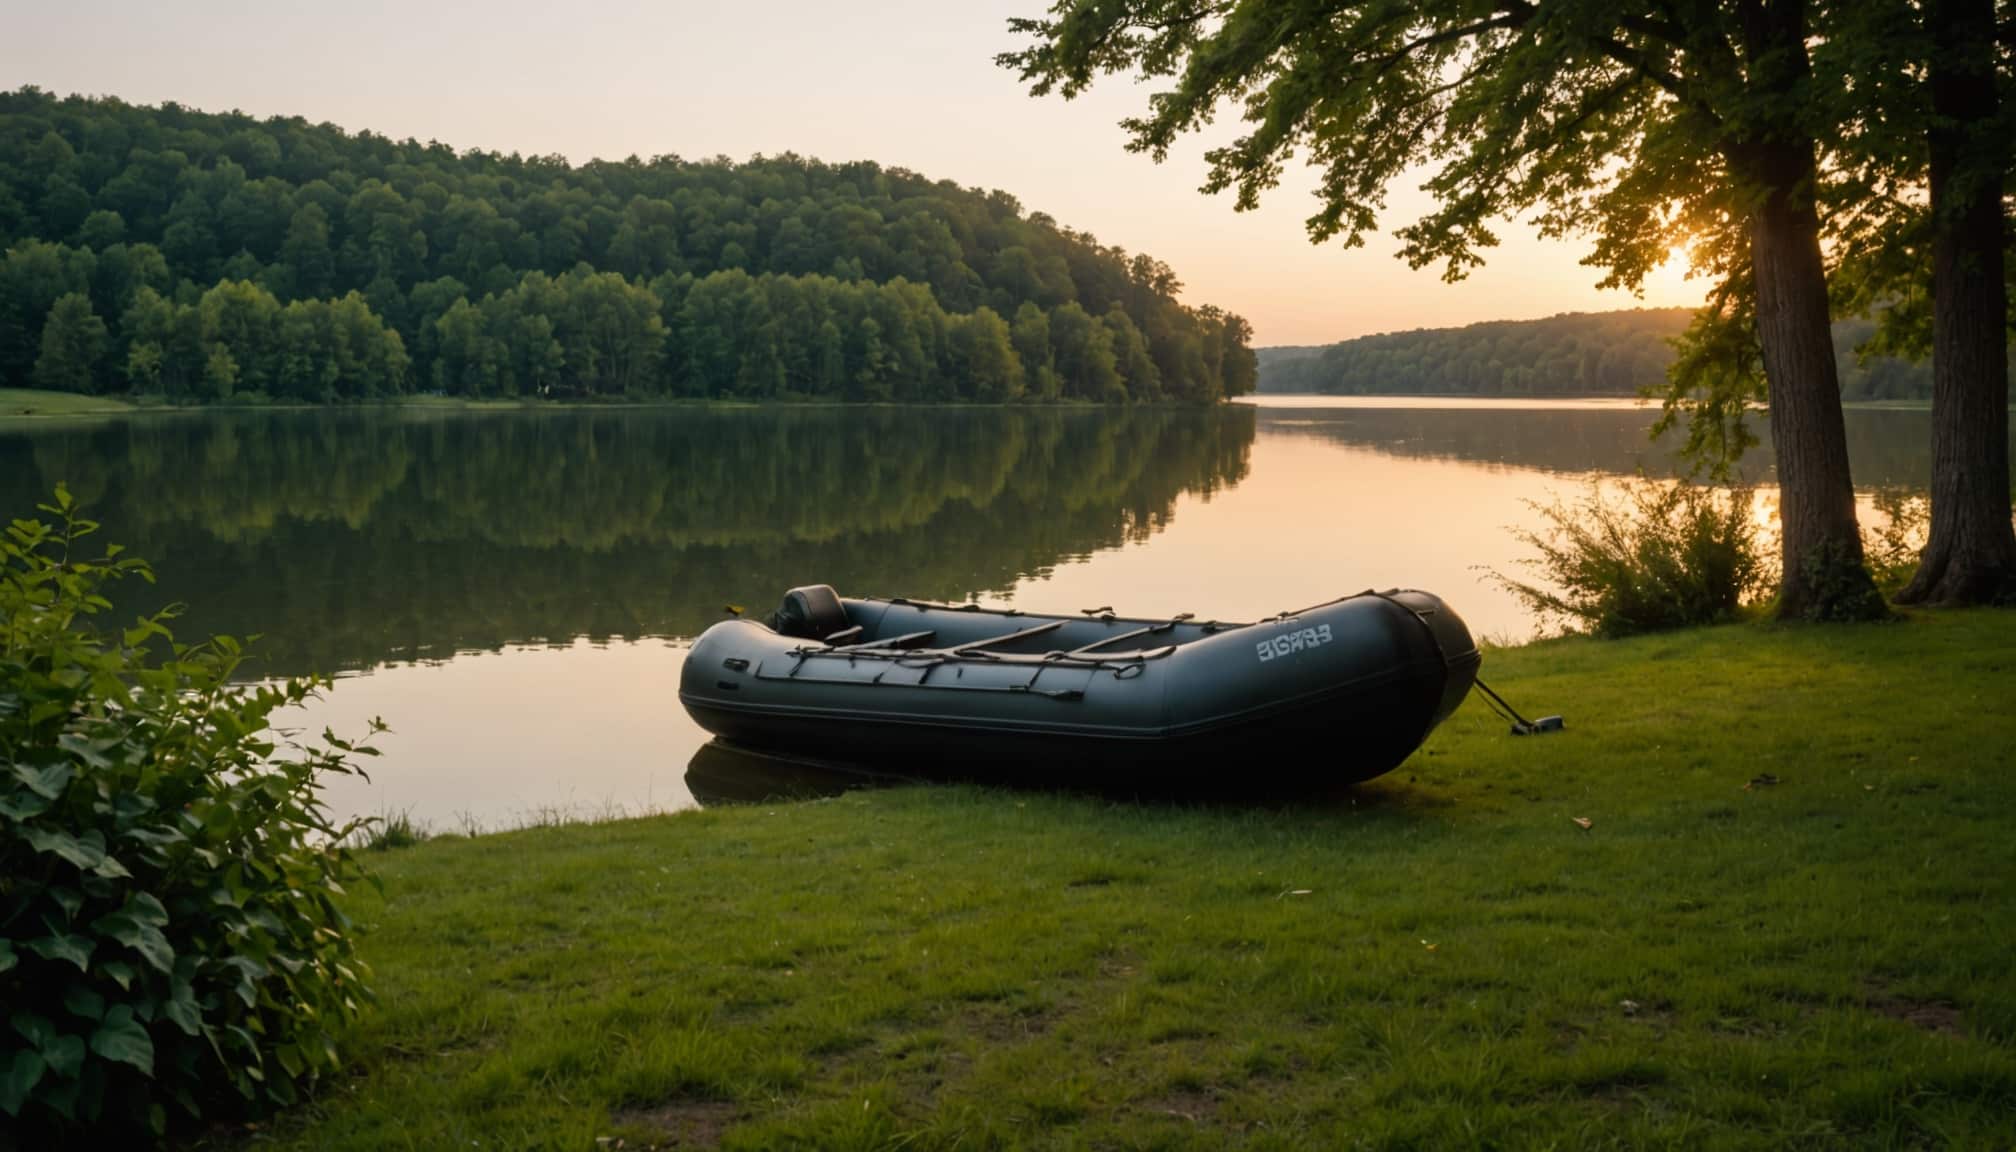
xmin=0 ymin=397 xmax=1967 ymax=829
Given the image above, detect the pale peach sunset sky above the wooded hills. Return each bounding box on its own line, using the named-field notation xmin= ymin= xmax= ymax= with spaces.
xmin=0 ymin=0 xmax=1699 ymax=345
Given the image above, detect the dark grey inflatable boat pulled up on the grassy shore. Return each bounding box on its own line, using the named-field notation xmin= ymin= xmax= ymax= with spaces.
xmin=679 ymin=585 xmax=1478 ymax=781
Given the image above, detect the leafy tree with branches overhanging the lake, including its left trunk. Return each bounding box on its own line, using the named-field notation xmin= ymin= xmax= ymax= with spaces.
xmin=998 ymin=0 xmax=1883 ymax=619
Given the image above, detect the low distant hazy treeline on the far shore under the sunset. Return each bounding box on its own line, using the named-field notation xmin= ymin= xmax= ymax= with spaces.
xmin=1260 ymin=309 xmax=1931 ymax=399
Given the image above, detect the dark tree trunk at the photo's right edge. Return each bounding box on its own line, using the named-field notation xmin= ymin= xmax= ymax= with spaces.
xmin=1897 ymin=0 xmax=2016 ymax=603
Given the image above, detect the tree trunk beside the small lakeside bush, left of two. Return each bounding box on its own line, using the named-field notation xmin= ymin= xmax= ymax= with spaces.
xmin=1726 ymin=0 xmax=1887 ymax=619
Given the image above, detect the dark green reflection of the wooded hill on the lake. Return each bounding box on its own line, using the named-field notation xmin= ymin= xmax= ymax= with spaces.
xmin=0 ymin=408 xmax=1254 ymax=676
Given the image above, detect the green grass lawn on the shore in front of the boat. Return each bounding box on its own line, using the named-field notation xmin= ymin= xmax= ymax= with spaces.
xmin=258 ymin=613 xmax=2016 ymax=1150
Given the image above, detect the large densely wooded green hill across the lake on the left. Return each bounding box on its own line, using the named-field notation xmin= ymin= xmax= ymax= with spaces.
xmin=0 ymin=87 xmax=1256 ymax=401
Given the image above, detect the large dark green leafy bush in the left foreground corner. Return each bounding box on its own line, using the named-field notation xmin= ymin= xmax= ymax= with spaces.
xmin=0 ymin=488 xmax=377 ymax=1146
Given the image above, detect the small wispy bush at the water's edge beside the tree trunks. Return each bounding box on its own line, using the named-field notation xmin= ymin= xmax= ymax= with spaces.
xmin=1490 ymin=478 xmax=1770 ymax=636
